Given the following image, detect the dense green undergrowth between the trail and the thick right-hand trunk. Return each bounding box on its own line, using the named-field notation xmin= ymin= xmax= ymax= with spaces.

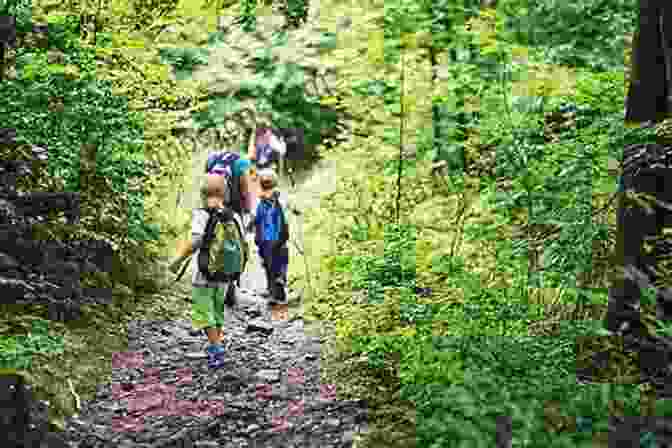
xmin=310 ymin=1 xmax=668 ymax=447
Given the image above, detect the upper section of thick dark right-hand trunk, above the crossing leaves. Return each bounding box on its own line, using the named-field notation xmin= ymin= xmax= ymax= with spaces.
xmin=625 ymin=0 xmax=672 ymax=123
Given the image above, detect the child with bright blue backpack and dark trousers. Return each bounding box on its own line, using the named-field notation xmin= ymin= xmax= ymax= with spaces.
xmin=254 ymin=169 xmax=301 ymax=303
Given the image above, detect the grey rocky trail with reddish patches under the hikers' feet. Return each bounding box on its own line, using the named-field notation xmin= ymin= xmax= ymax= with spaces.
xmin=59 ymin=248 xmax=366 ymax=448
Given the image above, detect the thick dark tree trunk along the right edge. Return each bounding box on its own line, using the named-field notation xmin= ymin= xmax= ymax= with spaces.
xmin=605 ymin=0 xmax=672 ymax=400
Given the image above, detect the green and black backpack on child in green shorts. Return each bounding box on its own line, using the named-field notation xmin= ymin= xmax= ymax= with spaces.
xmin=198 ymin=208 xmax=247 ymax=282
